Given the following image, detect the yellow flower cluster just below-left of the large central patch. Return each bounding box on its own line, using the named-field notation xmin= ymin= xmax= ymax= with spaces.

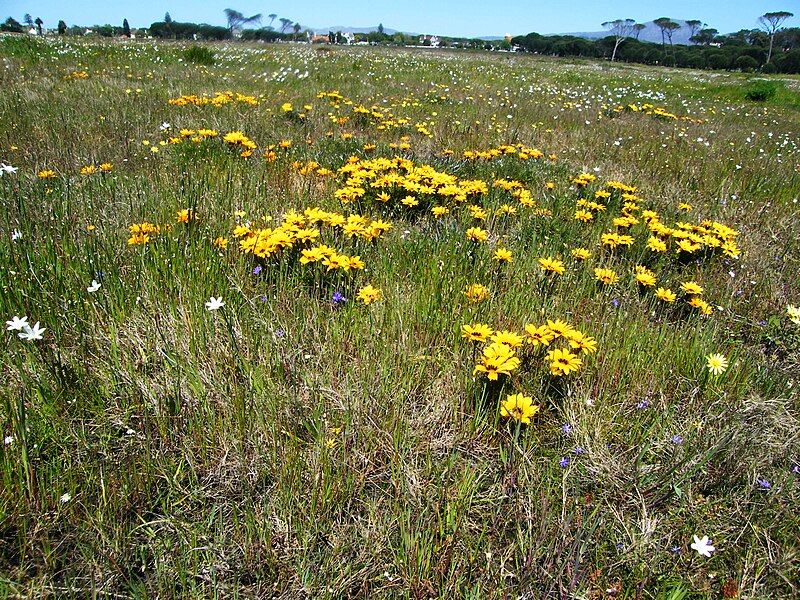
xmin=233 ymin=207 xmax=392 ymax=272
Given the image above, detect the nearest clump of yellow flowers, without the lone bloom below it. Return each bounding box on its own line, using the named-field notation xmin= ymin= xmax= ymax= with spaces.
xmin=461 ymin=319 xmax=597 ymax=381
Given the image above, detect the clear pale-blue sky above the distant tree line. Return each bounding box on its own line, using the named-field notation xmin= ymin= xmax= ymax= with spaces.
xmin=0 ymin=0 xmax=800 ymax=36
